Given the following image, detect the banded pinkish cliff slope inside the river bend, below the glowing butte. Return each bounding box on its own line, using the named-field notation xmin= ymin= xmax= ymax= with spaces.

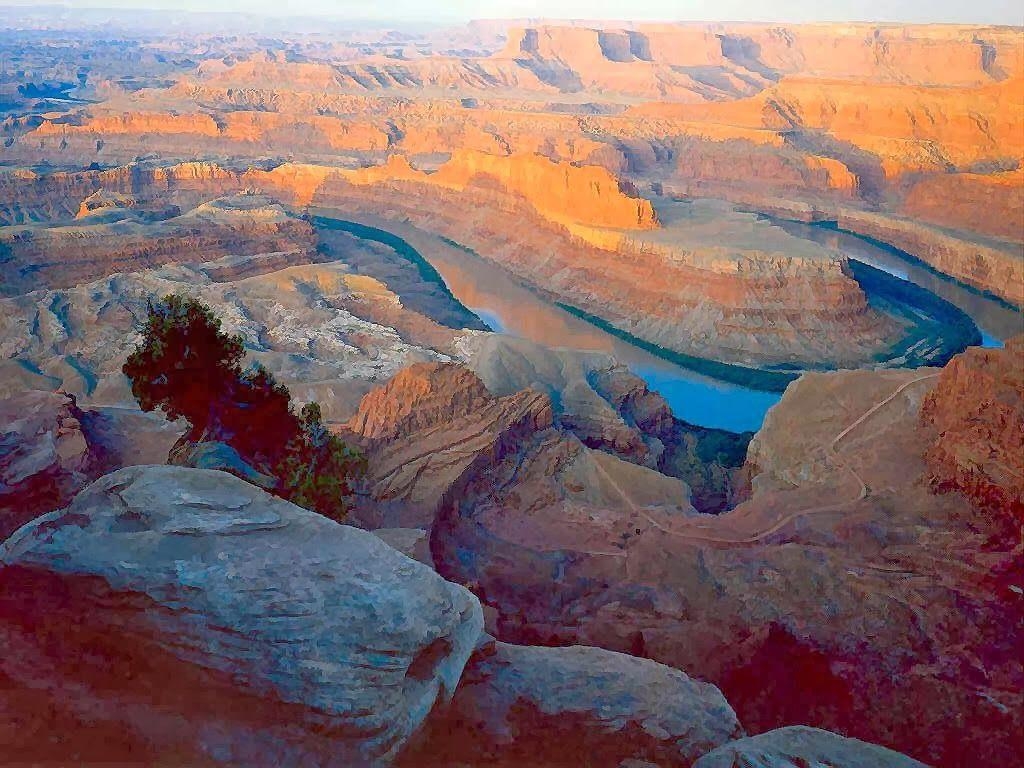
xmin=288 ymin=172 xmax=896 ymax=365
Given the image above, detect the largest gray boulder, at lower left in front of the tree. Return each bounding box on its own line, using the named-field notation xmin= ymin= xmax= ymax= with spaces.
xmin=0 ymin=466 xmax=482 ymax=766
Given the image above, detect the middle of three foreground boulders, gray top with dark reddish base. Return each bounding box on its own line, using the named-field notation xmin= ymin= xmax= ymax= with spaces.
xmin=409 ymin=643 xmax=742 ymax=768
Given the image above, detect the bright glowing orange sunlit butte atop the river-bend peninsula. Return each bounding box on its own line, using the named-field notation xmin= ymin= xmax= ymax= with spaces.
xmin=344 ymin=150 xmax=658 ymax=229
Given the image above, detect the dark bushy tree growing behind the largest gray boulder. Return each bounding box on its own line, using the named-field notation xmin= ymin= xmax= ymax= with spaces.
xmin=124 ymin=295 xmax=366 ymax=519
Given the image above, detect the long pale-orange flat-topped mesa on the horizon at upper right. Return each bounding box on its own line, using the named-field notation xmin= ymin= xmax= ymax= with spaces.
xmin=495 ymin=24 xmax=1022 ymax=88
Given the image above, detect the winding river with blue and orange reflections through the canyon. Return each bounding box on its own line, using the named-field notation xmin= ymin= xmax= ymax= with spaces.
xmin=316 ymin=212 xmax=1022 ymax=432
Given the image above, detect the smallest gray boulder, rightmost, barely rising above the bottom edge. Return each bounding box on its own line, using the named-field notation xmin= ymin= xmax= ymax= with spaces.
xmin=693 ymin=725 xmax=927 ymax=768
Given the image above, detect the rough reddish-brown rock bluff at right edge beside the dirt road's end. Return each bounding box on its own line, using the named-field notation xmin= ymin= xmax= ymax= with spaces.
xmin=921 ymin=336 xmax=1024 ymax=521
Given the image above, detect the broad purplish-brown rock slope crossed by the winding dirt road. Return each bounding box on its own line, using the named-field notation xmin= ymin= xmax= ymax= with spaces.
xmin=431 ymin=362 xmax=1024 ymax=765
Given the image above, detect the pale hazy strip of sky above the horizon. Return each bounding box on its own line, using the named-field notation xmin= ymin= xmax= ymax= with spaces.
xmin=6 ymin=0 xmax=1024 ymax=25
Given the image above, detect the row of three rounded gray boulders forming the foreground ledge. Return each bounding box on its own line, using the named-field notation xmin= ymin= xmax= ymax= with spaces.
xmin=0 ymin=466 xmax=933 ymax=768
